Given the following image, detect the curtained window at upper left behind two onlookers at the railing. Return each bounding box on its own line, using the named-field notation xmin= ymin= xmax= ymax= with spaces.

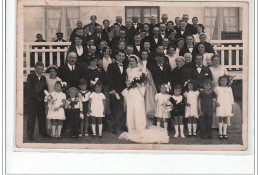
xmin=46 ymin=7 xmax=80 ymax=41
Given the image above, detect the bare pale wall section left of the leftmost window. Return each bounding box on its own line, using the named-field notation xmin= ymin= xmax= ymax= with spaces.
xmin=24 ymin=7 xmax=45 ymax=42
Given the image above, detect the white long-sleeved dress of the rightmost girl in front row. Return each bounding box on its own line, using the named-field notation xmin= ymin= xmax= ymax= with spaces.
xmin=215 ymin=86 xmax=234 ymax=117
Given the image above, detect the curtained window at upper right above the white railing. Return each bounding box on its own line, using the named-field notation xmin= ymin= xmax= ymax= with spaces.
xmin=204 ymin=7 xmax=239 ymax=40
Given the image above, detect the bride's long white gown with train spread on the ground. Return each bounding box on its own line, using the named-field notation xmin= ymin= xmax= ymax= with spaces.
xmin=119 ymin=67 xmax=169 ymax=143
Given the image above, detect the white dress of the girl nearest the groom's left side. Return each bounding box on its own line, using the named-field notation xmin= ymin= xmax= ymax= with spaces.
xmin=89 ymin=92 xmax=106 ymax=117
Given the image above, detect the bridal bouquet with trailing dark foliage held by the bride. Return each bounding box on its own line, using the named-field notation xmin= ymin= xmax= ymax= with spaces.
xmin=127 ymin=69 xmax=147 ymax=90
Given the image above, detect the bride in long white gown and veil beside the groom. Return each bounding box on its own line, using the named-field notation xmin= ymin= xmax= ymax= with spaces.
xmin=119 ymin=55 xmax=169 ymax=143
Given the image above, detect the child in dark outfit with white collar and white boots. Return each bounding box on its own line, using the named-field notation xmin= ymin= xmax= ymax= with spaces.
xmin=170 ymin=85 xmax=185 ymax=138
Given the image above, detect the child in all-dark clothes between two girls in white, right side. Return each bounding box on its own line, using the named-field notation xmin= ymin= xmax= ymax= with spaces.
xmin=199 ymin=80 xmax=216 ymax=139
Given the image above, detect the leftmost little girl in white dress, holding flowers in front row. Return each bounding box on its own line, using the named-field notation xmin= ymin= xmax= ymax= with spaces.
xmin=46 ymin=81 xmax=66 ymax=139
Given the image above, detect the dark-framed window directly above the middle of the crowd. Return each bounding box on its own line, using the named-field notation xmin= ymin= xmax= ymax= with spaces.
xmin=125 ymin=6 xmax=160 ymax=24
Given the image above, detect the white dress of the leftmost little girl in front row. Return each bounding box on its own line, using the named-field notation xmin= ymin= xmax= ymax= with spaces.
xmin=47 ymin=91 xmax=66 ymax=120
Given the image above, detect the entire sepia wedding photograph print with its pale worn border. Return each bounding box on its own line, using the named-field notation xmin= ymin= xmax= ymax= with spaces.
xmin=15 ymin=0 xmax=249 ymax=151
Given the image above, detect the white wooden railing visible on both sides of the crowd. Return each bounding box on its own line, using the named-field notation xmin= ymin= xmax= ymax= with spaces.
xmin=24 ymin=40 xmax=244 ymax=79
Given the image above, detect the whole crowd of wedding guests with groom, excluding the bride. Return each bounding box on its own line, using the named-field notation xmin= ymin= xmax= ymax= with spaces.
xmin=26 ymin=14 xmax=234 ymax=140
